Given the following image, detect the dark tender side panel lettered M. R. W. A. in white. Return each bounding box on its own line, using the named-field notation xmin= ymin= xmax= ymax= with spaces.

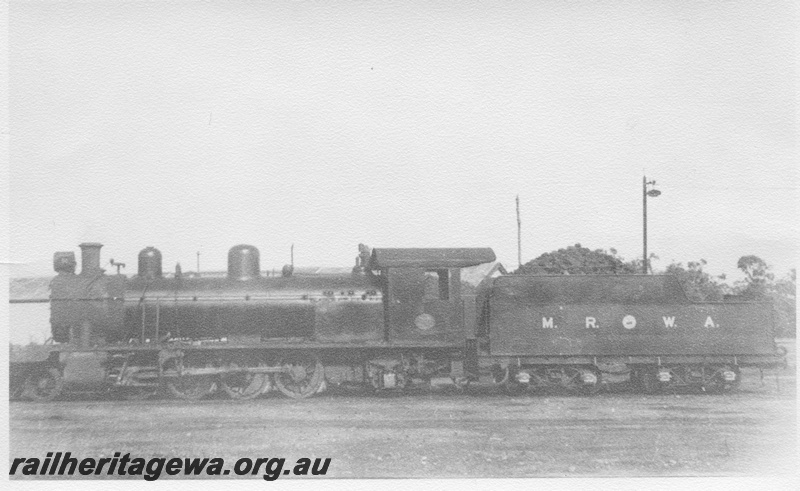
xmin=489 ymin=297 xmax=775 ymax=356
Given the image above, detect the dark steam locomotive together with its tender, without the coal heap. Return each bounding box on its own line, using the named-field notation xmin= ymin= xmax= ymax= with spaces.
xmin=10 ymin=243 xmax=782 ymax=401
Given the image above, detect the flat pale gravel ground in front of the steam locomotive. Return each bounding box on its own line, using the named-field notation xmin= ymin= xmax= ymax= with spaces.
xmin=10 ymin=371 xmax=797 ymax=478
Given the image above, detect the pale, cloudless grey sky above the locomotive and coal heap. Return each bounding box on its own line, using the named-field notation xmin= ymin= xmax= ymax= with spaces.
xmin=7 ymin=1 xmax=798 ymax=286
